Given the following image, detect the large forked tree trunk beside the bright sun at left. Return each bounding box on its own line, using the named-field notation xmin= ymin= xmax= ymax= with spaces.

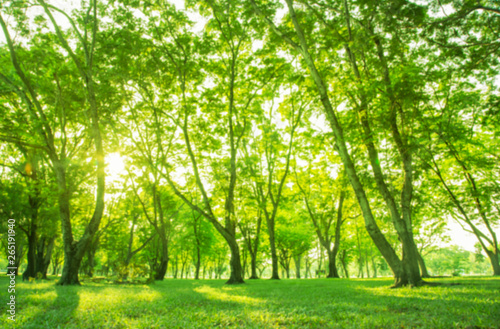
xmin=0 ymin=0 xmax=110 ymax=285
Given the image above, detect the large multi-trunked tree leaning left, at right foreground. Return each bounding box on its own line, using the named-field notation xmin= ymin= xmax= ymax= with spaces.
xmin=251 ymin=0 xmax=422 ymax=286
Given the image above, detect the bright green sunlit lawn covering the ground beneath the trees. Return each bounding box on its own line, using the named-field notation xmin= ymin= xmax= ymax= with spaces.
xmin=0 ymin=276 xmax=500 ymax=329
